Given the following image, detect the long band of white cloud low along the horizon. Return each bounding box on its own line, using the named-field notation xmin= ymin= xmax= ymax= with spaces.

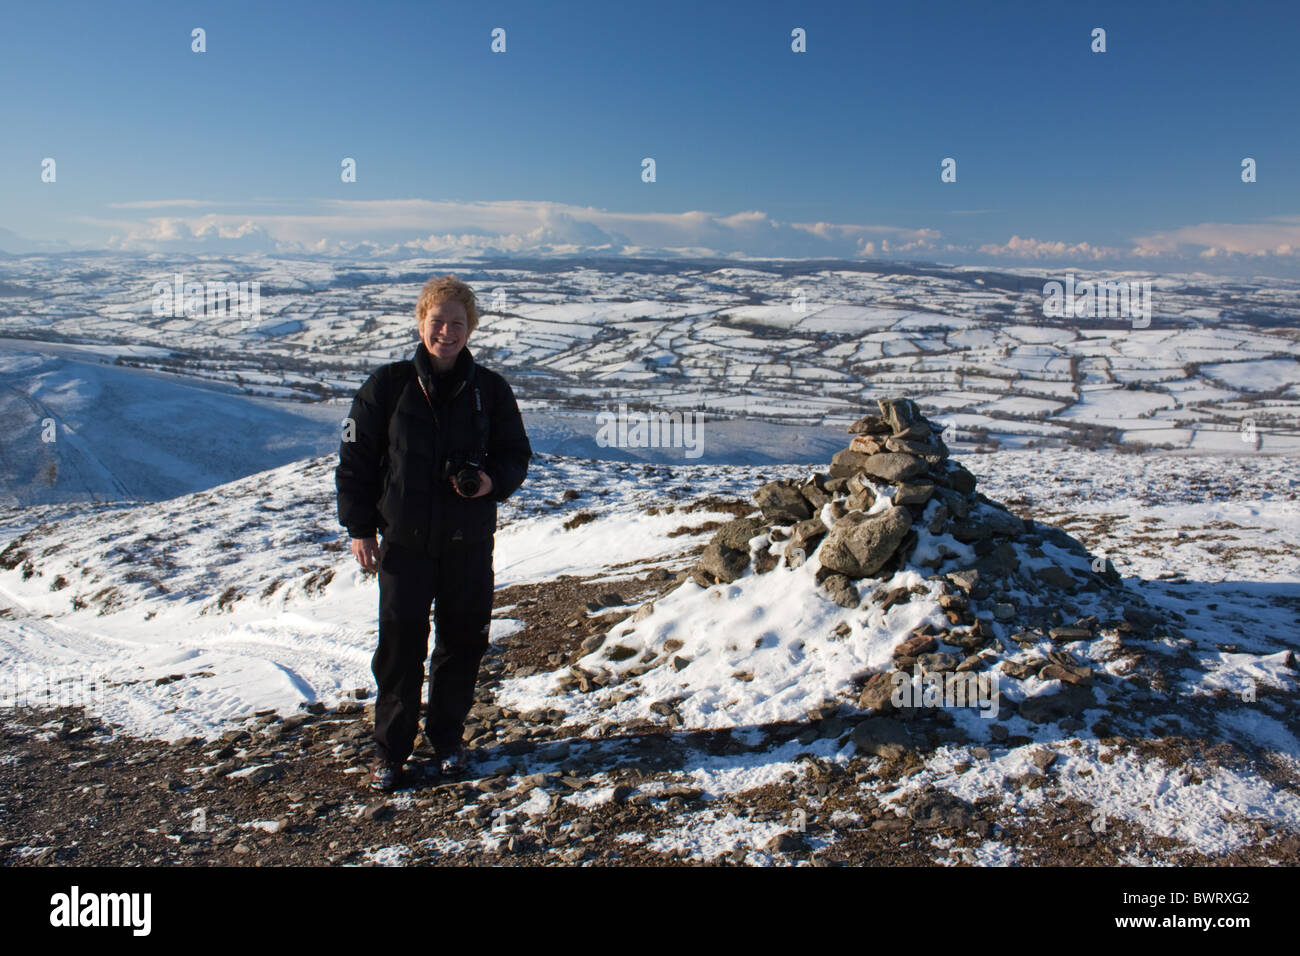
xmin=38 ymin=199 xmax=1300 ymax=277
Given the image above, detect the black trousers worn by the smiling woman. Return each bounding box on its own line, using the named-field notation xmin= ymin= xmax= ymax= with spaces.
xmin=371 ymin=537 xmax=494 ymax=761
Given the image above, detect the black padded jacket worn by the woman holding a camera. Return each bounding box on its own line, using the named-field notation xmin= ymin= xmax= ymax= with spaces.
xmin=334 ymin=342 xmax=533 ymax=555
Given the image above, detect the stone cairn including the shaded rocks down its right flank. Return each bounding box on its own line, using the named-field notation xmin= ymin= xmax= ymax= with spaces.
xmin=681 ymin=398 xmax=1119 ymax=710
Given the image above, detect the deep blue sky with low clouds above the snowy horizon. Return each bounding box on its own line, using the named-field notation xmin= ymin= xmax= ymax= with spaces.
xmin=0 ymin=1 xmax=1300 ymax=274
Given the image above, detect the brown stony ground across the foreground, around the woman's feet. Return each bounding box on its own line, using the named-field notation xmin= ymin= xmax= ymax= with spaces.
xmin=0 ymin=556 xmax=1300 ymax=866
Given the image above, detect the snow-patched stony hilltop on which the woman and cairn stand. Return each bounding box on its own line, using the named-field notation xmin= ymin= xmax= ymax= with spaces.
xmin=0 ymin=432 xmax=1300 ymax=864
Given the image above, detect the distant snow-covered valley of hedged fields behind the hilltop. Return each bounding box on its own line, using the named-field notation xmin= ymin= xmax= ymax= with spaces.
xmin=0 ymin=254 xmax=1300 ymax=515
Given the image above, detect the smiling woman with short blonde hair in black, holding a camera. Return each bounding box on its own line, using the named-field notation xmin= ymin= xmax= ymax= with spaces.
xmin=335 ymin=276 xmax=532 ymax=792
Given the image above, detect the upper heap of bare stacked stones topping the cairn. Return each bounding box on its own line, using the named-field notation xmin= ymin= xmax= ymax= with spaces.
xmin=690 ymin=398 xmax=1055 ymax=606
